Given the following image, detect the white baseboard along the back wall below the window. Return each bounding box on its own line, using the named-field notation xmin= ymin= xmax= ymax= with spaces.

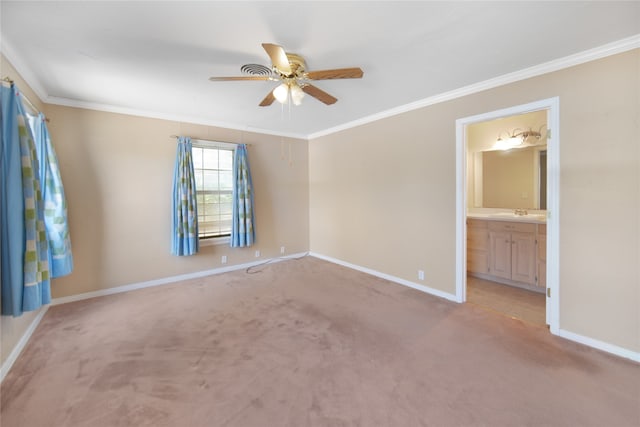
xmin=51 ymin=252 xmax=308 ymax=305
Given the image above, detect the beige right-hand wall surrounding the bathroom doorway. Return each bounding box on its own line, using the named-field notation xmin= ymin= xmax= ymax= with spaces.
xmin=309 ymin=50 xmax=640 ymax=351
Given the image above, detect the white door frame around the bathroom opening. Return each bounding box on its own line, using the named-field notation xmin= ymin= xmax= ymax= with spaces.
xmin=455 ymin=97 xmax=560 ymax=335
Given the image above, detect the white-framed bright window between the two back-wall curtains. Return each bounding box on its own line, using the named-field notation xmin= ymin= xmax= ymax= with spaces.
xmin=192 ymin=140 xmax=235 ymax=241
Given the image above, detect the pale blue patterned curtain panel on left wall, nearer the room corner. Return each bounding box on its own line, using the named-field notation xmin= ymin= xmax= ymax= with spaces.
xmin=32 ymin=113 xmax=73 ymax=278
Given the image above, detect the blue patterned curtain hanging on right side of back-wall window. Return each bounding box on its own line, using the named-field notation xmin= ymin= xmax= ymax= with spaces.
xmin=230 ymin=144 xmax=256 ymax=248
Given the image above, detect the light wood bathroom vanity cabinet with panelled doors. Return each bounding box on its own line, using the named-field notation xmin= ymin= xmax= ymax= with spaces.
xmin=467 ymin=218 xmax=546 ymax=292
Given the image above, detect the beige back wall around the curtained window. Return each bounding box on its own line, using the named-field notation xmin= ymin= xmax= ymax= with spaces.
xmin=47 ymin=105 xmax=309 ymax=298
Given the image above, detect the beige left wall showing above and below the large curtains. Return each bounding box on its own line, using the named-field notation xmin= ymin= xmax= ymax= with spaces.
xmin=0 ymin=55 xmax=48 ymax=364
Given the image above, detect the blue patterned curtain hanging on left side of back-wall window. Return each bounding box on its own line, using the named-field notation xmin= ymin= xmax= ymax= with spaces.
xmin=171 ymin=136 xmax=199 ymax=256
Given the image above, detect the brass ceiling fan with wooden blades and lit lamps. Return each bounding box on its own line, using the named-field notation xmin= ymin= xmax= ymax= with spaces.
xmin=209 ymin=43 xmax=363 ymax=107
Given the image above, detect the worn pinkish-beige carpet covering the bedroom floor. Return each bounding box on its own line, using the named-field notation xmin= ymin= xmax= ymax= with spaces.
xmin=0 ymin=258 xmax=640 ymax=427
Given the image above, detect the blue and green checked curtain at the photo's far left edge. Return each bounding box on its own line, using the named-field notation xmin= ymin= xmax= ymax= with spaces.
xmin=0 ymin=84 xmax=51 ymax=316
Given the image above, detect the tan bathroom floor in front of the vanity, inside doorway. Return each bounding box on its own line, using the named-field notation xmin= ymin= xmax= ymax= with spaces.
xmin=467 ymin=276 xmax=546 ymax=326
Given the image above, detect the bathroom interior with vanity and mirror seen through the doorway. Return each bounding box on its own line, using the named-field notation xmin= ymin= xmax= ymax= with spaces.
xmin=467 ymin=110 xmax=547 ymax=326
